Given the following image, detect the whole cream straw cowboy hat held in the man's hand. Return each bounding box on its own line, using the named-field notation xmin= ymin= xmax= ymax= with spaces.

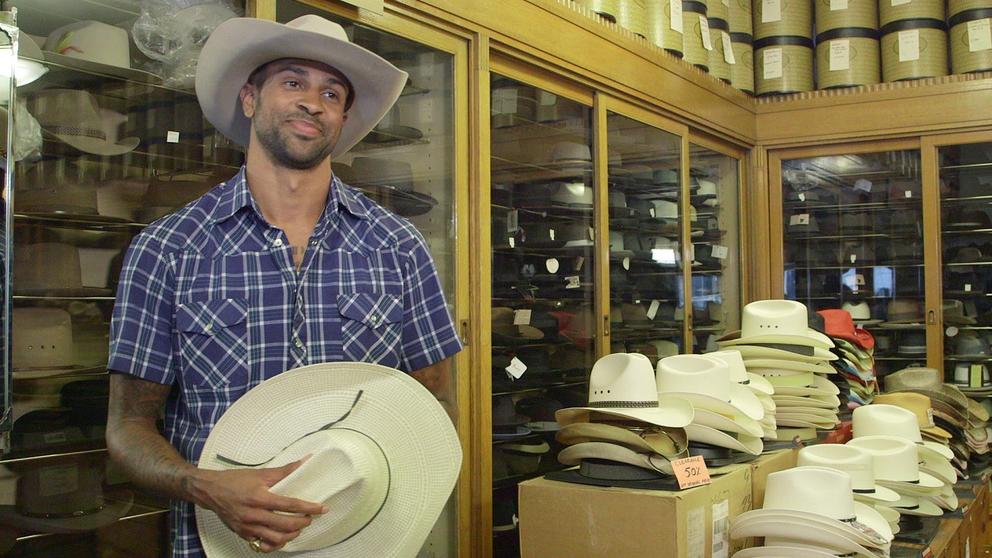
xmin=196 ymin=362 xmax=462 ymax=558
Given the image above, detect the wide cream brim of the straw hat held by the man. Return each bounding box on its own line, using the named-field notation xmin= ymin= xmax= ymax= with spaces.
xmin=196 ymin=362 xmax=462 ymax=558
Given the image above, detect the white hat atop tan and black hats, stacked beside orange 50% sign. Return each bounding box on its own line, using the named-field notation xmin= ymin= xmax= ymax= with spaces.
xmin=555 ymin=353 xmax=693 ymax=482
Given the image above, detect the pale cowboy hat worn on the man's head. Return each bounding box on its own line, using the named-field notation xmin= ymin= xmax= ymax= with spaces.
xmin=196 ymin=15 xmax=407 ymax=158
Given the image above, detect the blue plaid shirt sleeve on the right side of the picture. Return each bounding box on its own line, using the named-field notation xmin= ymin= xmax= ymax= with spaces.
xmin=401 ymin=234 xmax=462 ymax=372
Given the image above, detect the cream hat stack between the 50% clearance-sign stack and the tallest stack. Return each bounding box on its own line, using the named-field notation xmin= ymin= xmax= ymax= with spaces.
xmin=657 ymin=355 xmax=767 ymax=465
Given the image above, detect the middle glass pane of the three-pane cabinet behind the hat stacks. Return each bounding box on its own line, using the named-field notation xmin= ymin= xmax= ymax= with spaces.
xmin=606 ymin=113 xmax=685 ymax=365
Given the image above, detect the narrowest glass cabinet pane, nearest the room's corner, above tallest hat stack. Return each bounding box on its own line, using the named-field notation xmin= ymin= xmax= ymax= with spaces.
xmin=689 ymin=144 xmax=742 ymax=353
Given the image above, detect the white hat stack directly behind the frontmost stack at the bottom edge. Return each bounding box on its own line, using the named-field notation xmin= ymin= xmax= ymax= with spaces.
xmin=796 ymin=444 xmax=899 ymax=533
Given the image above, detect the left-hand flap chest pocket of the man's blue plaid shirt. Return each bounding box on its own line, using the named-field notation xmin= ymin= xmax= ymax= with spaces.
xmin=176 ymin=298 xmax=250 ymax=389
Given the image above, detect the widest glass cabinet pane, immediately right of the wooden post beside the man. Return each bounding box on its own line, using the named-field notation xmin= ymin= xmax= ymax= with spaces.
xmin=491 ymin=75 xmax=596 ymax=557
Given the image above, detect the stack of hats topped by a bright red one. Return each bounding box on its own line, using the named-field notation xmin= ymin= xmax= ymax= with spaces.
xmin=818 ymin=309 xmax=878 ymax=406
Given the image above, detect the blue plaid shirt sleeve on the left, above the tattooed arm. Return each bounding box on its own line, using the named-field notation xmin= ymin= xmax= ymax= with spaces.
xmin=107 ymin=234 xmax=175 ymax=384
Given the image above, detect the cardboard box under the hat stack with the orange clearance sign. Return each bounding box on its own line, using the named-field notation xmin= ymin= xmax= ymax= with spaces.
xmin=519 ymin=465 xmax=751 ymax=558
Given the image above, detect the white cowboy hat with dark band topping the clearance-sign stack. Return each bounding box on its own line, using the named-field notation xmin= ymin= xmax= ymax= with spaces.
xmin=555 ymin=353 xmax=693 ymax=428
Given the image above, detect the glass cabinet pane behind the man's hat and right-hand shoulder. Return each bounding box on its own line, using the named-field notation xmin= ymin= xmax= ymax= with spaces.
xmin=276 ymin=0 xmax=458 ymax=558
